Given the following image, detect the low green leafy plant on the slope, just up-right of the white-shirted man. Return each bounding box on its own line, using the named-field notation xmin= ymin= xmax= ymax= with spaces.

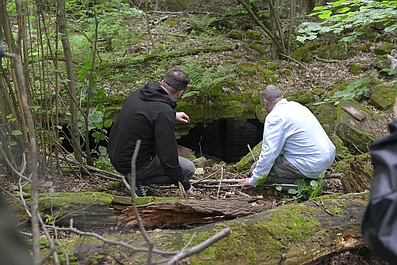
xmin=315 ymin=77 xmax=372 ymax=105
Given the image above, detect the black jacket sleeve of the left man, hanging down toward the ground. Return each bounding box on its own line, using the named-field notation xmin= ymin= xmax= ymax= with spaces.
xmin=154 ymin=111 xmax=190 ymax=190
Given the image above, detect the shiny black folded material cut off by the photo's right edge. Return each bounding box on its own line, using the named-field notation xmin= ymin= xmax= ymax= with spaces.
xmin=361 ymin=120 xmax=397 ymax=264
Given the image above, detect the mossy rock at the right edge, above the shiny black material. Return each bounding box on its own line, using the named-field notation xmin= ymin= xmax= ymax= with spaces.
xmin=368 ymin=85 xmax=397 ymax=110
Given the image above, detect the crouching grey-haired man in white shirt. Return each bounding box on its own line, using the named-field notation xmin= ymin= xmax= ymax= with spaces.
xmin=239 ymin=85 xmax=335 ymax=187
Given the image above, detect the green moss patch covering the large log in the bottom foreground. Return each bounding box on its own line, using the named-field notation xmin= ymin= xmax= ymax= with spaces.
xmin=184 ymin=205 xmax=320 ymax=264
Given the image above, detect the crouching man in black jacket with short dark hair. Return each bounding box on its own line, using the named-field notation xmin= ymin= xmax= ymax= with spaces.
xmin=108 ymin=68 xmax=195 ymax=196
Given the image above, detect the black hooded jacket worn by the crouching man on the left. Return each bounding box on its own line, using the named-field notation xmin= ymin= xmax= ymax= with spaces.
xmin=108 ymin=82 xmax=186 ymax=188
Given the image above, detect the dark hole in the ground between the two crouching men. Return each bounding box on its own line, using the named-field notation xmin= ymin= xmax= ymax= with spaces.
xmin=177 ymin=119 xmax=263 ymax=163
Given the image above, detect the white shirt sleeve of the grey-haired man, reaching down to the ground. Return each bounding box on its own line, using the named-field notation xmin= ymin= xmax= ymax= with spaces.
xmin=249 ymin=117 xmax=286 ymax=187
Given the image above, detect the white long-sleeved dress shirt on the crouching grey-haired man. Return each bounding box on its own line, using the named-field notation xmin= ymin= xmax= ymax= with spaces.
xmin=249 ymin=99 xmax=335 ymax=187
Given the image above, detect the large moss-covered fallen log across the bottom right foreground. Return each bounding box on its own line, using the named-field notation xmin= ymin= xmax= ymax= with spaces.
xmin=51 ymin=193 xmax=368 ymax=265
